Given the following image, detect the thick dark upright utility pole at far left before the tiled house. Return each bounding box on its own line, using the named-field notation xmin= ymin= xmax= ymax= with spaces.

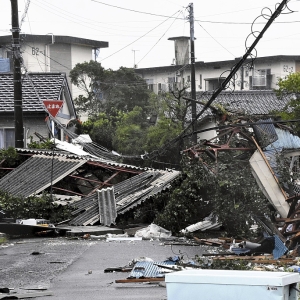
xmin=11 ymin=0 xmax=24 ymax=148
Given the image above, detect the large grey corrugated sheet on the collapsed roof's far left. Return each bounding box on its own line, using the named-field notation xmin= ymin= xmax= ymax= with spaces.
xmin=0 ymin=155 xmax=86 ymax=197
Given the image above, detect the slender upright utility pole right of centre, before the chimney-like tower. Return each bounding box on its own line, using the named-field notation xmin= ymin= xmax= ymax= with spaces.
xmin=189 ymin=3 xmax=197 ymax=144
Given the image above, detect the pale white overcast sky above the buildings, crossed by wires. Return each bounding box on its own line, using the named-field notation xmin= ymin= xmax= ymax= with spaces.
xmin=0 ymin=0 xmax=300 ymax=69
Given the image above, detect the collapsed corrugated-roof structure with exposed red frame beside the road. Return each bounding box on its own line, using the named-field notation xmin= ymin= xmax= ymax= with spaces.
xmin=0 ymin=127 xmax=180 ymax=226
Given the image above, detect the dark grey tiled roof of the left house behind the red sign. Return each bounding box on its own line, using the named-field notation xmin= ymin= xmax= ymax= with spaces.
xmin=0 ymin=73 xmax=76 ymax=116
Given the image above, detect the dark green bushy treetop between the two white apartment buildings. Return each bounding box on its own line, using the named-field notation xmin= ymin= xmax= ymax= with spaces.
xmin=70 ymin=60 xmax=150 ymax=116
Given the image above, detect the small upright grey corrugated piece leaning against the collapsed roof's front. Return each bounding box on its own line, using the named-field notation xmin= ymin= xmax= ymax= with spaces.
xmin=98 ymin=187 xmax=117 ymax=226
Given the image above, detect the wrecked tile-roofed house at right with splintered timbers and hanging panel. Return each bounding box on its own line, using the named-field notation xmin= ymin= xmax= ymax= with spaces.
xmin=185 ymin=91 xmax=300 ymax=244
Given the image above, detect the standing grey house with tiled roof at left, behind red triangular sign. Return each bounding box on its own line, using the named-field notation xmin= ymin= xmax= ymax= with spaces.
xmin=0 ymin=72 xmax=76 ymax=148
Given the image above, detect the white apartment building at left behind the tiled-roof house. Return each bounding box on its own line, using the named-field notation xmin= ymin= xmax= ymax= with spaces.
xmin=0 ymin=34 xmax=108 ymax=119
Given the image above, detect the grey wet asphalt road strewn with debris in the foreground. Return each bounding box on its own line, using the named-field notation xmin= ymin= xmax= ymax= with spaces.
xmin=0 ymin=237 xmax=207 ymax=300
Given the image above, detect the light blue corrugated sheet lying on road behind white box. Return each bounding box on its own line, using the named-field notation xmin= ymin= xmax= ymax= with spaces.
xmin=128 ymin=260 xmax=175 ymax=278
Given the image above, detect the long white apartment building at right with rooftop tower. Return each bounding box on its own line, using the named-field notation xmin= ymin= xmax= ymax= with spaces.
xmin=136 ymin=37 xmax=300 ymax=93
